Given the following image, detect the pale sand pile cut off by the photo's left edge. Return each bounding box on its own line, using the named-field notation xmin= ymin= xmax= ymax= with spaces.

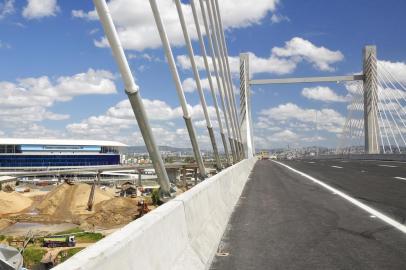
xmin=0 ymin=191 xmax=32 ymax=216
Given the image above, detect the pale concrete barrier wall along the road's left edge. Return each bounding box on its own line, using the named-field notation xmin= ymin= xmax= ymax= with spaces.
xmin=53 ymin=158 xmax=257 ymax=270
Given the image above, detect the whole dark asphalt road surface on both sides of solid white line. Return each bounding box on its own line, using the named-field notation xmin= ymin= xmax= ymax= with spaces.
xmin=211 ymin=160 xmax=406 ymax=270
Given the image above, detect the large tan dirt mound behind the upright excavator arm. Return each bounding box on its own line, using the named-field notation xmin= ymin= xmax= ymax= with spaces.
xmin=37 ymin=183 xmax=112 ymax=220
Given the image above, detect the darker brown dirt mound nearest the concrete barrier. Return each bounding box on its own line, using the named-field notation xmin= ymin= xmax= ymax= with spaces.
xmin=83 ymin=197 xmax=138 ymax=228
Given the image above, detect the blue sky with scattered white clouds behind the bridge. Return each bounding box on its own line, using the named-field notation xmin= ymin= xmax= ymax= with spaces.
xmin=0 ymin=0 xmax=406 ymax=149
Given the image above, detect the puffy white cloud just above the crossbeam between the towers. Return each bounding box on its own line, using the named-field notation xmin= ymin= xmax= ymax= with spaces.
xmin=272 ymin=37 xmax=344 ymax=71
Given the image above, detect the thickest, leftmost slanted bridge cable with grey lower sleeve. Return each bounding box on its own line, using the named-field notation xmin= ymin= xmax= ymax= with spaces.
xmin=93 ymin=0 xmax=170 ymax=196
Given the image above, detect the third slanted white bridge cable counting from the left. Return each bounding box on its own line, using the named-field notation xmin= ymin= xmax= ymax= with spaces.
xmin=175 ymin=0 xmax=223 ymax=170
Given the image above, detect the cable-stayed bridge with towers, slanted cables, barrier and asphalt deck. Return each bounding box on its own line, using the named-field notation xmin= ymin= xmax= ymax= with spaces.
xmin=56 ymin=0 xmax=406 ymax=270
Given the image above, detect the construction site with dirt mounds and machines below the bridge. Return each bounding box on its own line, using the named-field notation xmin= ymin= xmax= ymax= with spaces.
xmin=0 ymin=168 xmax=205 ymax=269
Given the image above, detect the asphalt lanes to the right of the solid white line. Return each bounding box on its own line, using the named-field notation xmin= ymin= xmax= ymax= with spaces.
xmin=283 ymin=160 xmax=406 ymax=223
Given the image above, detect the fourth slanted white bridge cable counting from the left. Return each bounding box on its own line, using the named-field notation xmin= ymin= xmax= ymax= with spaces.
xmin=190 ymin=0 xmax=231 ymax=164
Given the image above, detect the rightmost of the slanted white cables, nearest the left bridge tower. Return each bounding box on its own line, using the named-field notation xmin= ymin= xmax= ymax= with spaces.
xmin=213 ymin=0 xmax=244 ymax=158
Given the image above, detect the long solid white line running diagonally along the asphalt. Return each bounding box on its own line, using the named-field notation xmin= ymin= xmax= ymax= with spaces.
xmin=273 ymin=161 xmax=406 ymax=233
